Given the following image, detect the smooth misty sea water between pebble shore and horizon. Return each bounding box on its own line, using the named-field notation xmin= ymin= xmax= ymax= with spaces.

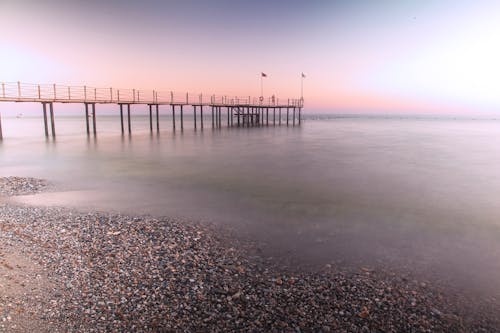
xmin=0 ymin=113 xmax=500 ymax=295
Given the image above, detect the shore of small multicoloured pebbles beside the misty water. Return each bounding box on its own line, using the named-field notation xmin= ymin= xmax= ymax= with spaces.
xmin=0 ymin=178 xmax=500 ymax=332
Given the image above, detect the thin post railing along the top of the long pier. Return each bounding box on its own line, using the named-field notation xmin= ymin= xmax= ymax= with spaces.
xmin=0 ymin=82 xmax=303 ymax=107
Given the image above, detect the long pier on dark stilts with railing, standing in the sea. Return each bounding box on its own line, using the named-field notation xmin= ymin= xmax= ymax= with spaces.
xmin=0 ymin=82 xmax=304 ymax=140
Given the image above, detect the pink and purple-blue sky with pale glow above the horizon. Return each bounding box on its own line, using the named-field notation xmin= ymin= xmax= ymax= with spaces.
xmin=0 ymin=0 xmax=500 ymax=114
